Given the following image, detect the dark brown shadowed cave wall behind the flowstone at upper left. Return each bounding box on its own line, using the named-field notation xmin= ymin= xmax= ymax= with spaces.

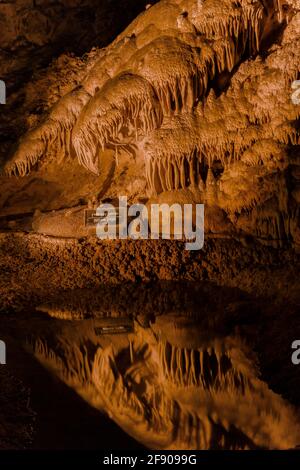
xmin=0 ymin=0 xmax=155 ymax=89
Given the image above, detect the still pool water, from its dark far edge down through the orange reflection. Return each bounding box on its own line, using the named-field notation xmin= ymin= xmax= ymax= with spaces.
xmin=19 ymin=283 xmax=300 ymax=449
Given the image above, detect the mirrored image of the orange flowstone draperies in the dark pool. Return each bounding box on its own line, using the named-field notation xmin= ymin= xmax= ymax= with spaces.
xmin=27 ymin=316 xmax=299 ymax=449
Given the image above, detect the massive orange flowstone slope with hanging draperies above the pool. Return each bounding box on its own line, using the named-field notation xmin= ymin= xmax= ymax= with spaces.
xmin=4 ymin=0 xmax=300 ymax=246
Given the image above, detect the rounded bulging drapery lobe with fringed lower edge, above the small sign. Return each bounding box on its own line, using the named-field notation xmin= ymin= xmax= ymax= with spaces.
xmin=73 ymin=73 xmax=162 ymax=173
